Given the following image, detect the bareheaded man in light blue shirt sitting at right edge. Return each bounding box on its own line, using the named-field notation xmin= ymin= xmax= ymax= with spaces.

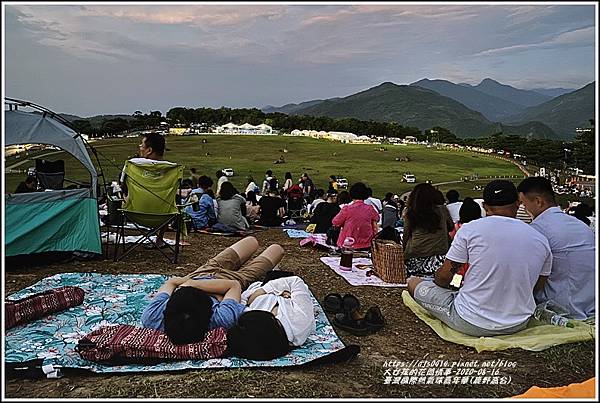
xmin=517 ymin=176 xmax=596 ymax=320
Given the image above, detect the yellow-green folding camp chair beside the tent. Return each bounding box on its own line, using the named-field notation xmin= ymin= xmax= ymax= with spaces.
xmin=114 ymin=161 xmax=185 ymax=263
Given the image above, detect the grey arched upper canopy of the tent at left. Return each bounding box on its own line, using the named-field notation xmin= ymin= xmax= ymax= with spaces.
xmin=4 ymin=111 xmax=98 ymax=196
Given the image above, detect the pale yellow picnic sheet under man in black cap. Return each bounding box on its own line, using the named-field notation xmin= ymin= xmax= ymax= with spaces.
xmin=402 ymin=291 xmax=595 ymax=353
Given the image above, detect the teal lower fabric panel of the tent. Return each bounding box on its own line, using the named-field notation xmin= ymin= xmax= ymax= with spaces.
xmin=5 ymin=197 xmax=102 ymax=256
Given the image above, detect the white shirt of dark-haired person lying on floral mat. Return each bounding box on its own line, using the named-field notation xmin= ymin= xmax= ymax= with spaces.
xmin=241 ymin=276 xmax=317 ymax=346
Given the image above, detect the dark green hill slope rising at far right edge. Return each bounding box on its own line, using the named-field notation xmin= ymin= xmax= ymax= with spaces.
xmin=507 ymin=82 xmax=596 ymax=139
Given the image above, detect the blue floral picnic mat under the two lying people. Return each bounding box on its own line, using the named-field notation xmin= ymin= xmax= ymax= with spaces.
xmin=4 ymin=273 xmax=346 ymax=373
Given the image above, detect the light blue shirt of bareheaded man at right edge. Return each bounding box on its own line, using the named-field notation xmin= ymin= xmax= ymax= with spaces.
xmin=530 ymin=207 xmax=596 ymax=320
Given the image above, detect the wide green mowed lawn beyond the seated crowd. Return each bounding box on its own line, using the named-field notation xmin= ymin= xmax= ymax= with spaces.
xmin=5 ymin=135 xmax=523 ymax=198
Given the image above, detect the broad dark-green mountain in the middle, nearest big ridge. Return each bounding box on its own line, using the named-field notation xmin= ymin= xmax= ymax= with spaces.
xmin=294 ymin=82 xmax=554 ymax=138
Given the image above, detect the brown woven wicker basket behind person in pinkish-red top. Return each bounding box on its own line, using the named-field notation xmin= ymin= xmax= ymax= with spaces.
xmin=371 ymin=238 xmax=406 ymax=284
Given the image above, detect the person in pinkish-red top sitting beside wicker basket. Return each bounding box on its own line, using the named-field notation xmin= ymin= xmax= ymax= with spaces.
xmin=332 ymin=182 xmax=379 ymax=249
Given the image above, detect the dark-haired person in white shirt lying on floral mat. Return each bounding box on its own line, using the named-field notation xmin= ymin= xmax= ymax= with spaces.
xmin=227 ymin=276 xmax=316 ymax=360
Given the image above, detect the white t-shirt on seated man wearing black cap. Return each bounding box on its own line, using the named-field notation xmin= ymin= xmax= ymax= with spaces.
xmin=446 ymin=216 xmax=552 ymax=330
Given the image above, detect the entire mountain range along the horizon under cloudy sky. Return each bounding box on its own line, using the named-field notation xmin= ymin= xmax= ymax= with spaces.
xmin=263 ymin=78 xmax=595 ymax=139
